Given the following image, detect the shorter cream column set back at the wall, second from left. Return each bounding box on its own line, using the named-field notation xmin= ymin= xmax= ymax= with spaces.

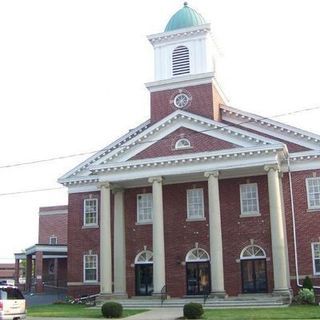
xmin=113 ymin=189 xmax=127 ymax=296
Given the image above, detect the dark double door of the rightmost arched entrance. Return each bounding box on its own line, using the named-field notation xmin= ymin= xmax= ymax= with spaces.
xmin=241 ymin=259 xmax=268 ymax=293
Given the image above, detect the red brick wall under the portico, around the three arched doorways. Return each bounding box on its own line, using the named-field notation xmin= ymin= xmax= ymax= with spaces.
xmin=125 ymin=176 xmax=273 ymax=297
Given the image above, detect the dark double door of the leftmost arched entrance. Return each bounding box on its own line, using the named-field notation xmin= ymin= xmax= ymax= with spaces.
xmin=136 ymin=263 xmax=153 ymax=296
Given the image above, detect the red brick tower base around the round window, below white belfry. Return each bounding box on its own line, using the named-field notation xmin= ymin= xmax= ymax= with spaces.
xmin=151 ymin=84 xmax=213 ymax=123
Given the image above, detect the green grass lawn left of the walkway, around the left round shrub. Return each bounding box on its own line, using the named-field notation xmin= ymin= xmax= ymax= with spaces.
xmin=27 ymin=304 xmax=146 ymax=318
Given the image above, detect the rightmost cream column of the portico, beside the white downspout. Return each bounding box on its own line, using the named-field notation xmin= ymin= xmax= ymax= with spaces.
xmin=265 ymin=165 xmax=289 ymax=293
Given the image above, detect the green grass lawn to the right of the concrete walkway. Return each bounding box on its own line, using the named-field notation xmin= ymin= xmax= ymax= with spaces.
xmin=203 ymin=306 xmax=320 ymax=320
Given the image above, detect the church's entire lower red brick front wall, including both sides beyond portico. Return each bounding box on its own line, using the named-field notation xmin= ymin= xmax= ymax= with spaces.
xmin=68 ymin=170 xmax=320 ymax=297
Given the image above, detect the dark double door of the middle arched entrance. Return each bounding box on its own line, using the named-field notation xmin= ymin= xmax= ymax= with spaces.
xmin=186 ymin=261 xmax=210 ymax=295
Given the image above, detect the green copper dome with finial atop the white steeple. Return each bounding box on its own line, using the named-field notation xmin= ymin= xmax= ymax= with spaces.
xmin=164 ymin=2 xmax=206 ymax=32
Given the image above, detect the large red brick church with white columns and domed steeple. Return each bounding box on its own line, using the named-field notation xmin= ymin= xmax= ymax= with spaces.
xmin=59 ymin=3 xmax=320 ymax=297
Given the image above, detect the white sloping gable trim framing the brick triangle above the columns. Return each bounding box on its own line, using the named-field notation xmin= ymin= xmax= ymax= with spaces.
xmin=58 ymin=110 xmax=283 ymax=185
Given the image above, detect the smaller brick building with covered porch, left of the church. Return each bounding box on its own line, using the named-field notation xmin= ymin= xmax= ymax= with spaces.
xmin=15 ymin=206 xmax=68 ymax=292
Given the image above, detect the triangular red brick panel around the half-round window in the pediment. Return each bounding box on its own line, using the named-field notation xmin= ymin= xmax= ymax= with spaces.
xmin=131 ymin=128 xmax=238 ymax=160
